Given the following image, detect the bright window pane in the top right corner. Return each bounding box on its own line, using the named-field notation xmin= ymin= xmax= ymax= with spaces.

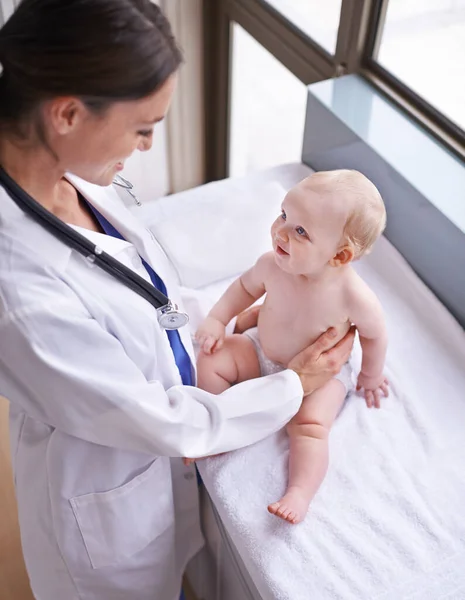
xmin=374 ymin=0 xmax=465 ymax=130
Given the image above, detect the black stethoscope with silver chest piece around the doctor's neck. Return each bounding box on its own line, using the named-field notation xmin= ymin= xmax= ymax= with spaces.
xmin=0 ymin=166 xmax=189 ymax=329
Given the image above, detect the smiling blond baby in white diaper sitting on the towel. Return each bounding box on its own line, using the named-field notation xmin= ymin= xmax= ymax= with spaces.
xmin=196 ymin=170 xmax=388 ymax=523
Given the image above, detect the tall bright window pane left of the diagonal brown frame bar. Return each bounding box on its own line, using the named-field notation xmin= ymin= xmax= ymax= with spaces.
xmin=229 ymin=23 xmax=307 ymax=177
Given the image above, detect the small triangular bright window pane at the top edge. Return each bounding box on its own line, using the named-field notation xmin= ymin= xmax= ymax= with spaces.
xmin=267 ymin=0 xmax=342 ymax=54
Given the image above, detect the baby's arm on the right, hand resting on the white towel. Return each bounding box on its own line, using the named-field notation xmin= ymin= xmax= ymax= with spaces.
xmin=349 ymin=280 xmax=388 ymax=408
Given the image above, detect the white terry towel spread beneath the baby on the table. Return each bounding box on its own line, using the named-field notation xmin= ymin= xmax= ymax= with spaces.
xmin=196 ymin=239 xmax=465 ymax=600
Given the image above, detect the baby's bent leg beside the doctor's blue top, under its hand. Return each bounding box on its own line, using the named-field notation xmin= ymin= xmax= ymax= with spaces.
xmin=197 ymin=334 xmax=260 ymax=394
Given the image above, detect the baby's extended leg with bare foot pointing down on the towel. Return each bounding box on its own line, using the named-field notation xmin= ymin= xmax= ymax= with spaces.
xmin=268 ymin=379 xmax=346 ymax=523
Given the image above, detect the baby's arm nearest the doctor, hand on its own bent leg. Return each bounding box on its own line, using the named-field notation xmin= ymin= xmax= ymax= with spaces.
xmin=196 ymin=253 xmax=273 ymax=354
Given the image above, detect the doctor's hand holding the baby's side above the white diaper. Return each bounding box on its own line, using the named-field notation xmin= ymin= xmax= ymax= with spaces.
xmin=288 ymin=327 xmax=355 ymax=396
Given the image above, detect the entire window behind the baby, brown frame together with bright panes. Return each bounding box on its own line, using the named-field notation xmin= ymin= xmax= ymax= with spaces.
xmin=203 ymin=0 xmax=465 ymax=179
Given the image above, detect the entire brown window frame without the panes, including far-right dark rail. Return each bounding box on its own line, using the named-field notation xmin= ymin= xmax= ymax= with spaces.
xmin=203 ymin=0 xmax=465 ymax=181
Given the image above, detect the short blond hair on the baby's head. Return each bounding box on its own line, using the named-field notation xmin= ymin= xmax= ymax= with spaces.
xmin=311 ymin=169 xmax=386 ymax=260
